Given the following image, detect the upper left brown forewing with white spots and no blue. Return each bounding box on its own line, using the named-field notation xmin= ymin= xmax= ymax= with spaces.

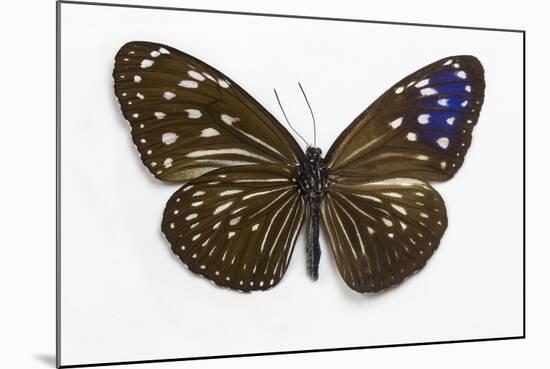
xmin=113 ymin=42 xmax=303 ymax=181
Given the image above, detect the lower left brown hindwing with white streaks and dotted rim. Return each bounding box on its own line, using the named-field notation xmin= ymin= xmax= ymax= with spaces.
xmin=162 ymin=165 xmax=305 ymax=291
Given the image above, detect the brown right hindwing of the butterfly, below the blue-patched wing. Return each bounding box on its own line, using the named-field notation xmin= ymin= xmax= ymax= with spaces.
xmin=322 ymin=178 xmax=447 ymax=292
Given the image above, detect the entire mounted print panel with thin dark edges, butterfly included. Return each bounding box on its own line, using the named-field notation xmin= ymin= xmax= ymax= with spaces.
xmin=58 ymin=3 xmax=524 ymax=365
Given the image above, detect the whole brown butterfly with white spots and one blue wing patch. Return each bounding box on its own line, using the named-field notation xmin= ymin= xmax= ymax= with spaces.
xmin=113 ymin=42 xmax=485 ymax=293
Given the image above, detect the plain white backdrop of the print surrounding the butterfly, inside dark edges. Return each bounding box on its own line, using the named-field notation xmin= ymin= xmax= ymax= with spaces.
xmin=57 ymin=4 xmax=523 ymax=364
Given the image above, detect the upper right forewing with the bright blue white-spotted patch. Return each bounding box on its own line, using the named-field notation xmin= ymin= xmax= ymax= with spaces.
xmin=327 ymin=56 xmax=485 ymax=181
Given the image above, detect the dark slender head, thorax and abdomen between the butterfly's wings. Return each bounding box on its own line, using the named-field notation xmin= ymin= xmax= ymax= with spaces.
xmin=297 ymin=147 xmax=328 ymax=280
